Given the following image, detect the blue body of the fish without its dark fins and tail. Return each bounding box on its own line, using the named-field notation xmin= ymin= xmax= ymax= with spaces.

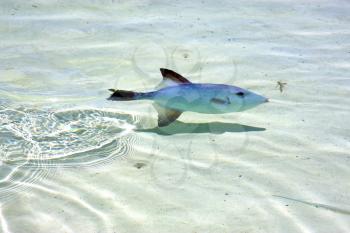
xmin=138 ymin=83 xmax=266 ymax=114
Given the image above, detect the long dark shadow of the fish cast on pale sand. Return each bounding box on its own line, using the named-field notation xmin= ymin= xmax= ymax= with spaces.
xmin=137 ymin=121 xmax=266 ymax=135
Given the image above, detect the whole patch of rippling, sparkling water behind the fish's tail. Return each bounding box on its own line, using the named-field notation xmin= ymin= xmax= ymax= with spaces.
xmin=0 ymin=109 xmax=142 ymax=202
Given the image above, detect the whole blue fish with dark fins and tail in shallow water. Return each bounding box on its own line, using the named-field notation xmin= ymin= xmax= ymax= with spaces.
xmin=107 ymin=68 xmax=269 ymax=127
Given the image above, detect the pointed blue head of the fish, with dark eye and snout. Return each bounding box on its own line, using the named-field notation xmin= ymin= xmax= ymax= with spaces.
xmin=230 ymin=88 xmax=269 ymax=112
